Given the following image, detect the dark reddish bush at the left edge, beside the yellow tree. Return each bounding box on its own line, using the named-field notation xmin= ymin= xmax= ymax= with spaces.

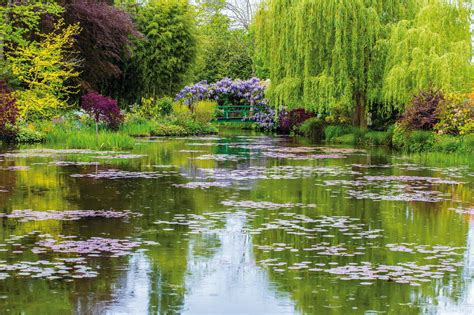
xmin=0 ymin=80 xmax=18 ymax=139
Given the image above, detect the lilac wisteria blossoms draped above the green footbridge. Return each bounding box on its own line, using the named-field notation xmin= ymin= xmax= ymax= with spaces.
xmin=175 ymin=78 xmax=267 ymax=107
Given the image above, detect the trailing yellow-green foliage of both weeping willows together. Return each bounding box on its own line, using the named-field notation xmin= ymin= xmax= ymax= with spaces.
xmin=255 ymin=0 xmax=471 ymax=127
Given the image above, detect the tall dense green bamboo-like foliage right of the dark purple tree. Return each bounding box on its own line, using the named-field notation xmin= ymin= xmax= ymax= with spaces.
xmin=118 ymin=0 xmax=197 ymax=103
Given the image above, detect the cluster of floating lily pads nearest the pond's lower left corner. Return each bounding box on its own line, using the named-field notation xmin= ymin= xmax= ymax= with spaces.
xmin=0 ymin=231 xmax=158 ymax=281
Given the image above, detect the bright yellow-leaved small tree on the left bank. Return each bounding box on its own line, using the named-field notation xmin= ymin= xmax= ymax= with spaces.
xmin=7 ymin=20 xmax=79 ymax=120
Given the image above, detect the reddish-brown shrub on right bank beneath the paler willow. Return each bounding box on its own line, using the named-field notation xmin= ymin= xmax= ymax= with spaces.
xmin=400 ymin=90 xmax=444 ymax=130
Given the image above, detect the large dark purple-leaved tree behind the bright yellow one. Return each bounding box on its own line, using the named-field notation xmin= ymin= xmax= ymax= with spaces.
xmin=61 ymin=0 xmax=139 ymax=89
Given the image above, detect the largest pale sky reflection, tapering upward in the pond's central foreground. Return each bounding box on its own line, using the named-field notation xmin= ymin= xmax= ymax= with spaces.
xmin=183 ymin=214 xmax=294 ymax=314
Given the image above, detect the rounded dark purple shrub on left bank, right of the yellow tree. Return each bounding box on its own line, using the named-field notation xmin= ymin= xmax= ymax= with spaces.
xmin=81 ymin=91 xmax=123 ymax=129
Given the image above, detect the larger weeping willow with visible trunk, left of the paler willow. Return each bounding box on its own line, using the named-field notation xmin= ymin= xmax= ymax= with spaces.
xmin=255 ymin=0 xmax=469 ymax=126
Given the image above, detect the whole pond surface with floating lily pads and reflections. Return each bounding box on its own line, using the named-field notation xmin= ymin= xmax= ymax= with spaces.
xmin=0 ymin=133 xmax=474 ymax=314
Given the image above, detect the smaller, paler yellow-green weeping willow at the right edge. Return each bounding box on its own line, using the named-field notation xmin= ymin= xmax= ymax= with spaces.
xmin=382 ymin=1 xmax=474 ymax=109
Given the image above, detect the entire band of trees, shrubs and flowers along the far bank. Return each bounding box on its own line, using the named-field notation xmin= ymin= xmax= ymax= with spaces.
xmin=0 ymin=0 xmax=474 ymax=151
